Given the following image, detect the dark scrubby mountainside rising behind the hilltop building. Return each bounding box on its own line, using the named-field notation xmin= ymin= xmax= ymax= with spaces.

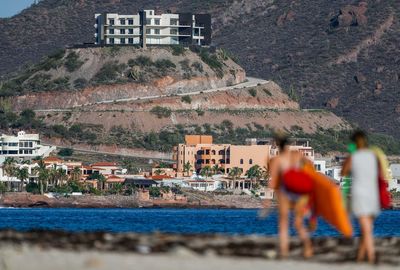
xmin=0 ymin=0 xmax=400 ymax=138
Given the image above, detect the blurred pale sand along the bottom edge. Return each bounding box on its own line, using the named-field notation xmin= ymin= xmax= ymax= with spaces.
xmin=0 ymin=247 xmax=398 ymax=270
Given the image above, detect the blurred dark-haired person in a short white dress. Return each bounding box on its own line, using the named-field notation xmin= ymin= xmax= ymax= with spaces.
xmin=342 ymin=131 xmax=380 ymax=263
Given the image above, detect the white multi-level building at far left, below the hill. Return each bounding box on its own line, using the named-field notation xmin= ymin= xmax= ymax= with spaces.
xmin=0 ymin=131 xmax=55 ymax=159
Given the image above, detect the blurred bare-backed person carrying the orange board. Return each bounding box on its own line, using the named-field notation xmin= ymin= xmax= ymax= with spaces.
xmin=260 ymin=136 xmax=313 ymax=258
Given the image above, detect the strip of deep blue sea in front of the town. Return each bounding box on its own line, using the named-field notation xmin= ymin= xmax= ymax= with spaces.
xmin=0 ymin=208 xmax=400 ymax=237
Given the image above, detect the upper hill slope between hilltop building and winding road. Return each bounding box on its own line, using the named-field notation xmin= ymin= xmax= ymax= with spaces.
xmin=0 ymin=47 xmax=246 ymax=110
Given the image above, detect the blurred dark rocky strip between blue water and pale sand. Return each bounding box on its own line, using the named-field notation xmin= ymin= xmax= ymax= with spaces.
xmin=0 ymin=230 xmax=400 ymax=266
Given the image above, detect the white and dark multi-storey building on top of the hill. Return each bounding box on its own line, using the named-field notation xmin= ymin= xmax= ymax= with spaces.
xmin=95 ymin=10 xmax=211 ymax=47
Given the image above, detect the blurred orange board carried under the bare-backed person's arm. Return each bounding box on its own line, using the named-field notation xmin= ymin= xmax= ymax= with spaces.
xmin=304 ymin=165 xmax=353 ymax=237
